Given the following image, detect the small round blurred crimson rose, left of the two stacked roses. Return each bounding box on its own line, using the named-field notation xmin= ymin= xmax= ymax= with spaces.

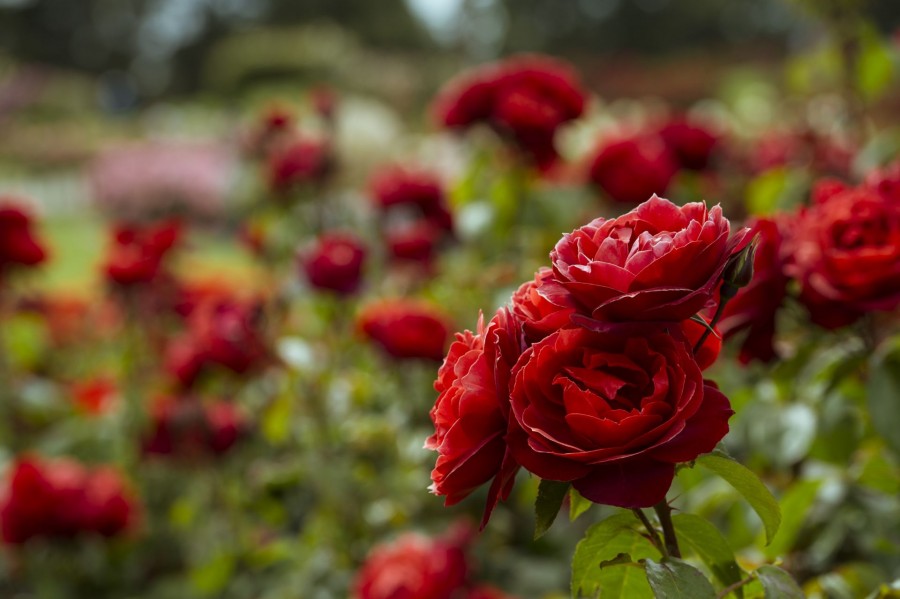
xmin=300 ymin=232 xmax=366 ymax=295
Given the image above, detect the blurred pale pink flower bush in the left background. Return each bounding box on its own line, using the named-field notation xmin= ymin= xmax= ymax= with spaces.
xmin=88 ymin=141 xmax=234 ymax=219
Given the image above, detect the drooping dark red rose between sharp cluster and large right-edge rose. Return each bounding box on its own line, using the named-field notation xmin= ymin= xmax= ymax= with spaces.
xmin=718 ymin=218 xmax=789 ymax=364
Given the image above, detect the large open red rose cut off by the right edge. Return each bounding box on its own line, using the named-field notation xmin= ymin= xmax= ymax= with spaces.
xmin=786 ymin=188 xmax=900 ymax=329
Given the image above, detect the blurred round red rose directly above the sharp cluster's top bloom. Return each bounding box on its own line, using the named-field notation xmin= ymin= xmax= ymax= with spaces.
xmin=588 ymin=134 xmax=678 ymax=204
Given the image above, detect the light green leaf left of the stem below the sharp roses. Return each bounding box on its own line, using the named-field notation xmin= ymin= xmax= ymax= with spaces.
xmin=572 ymin=512 xmax=659 ymax=599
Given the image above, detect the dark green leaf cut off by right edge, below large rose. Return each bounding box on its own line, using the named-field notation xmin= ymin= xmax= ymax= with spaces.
xmin=866 ymin=337 xmax=900 ymax=454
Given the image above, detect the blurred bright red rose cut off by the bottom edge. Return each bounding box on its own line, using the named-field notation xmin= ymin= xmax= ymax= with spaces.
xmin=352 ymin=533 xmax=468 ymax=599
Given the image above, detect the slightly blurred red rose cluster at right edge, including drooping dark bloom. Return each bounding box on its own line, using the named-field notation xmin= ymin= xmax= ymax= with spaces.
xmin=721 ymin=163 xmax=900 ymax=362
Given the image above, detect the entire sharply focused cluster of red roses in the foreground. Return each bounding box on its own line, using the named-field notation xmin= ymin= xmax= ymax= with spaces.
xmin=426 ymin=196 xmax=749 ymax=525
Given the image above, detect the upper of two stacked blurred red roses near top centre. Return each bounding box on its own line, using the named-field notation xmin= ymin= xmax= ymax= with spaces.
xmin=369 ymin=165 xmax=453 ymax=232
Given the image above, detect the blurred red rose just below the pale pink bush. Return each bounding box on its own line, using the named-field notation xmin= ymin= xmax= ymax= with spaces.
xmin=104 ymin=220 xmax=181 ymax=287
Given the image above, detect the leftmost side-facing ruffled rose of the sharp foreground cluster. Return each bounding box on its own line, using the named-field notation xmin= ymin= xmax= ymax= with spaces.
xmin=425 ymin=308 xmax=524 ymax=527
